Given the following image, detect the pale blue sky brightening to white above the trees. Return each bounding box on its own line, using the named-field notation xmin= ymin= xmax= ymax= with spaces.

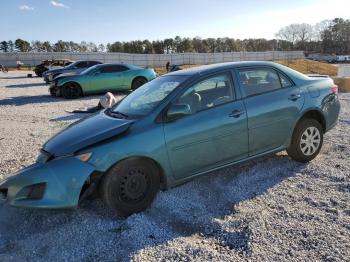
xmin=0 ymin=0 xmax=350 ymax=44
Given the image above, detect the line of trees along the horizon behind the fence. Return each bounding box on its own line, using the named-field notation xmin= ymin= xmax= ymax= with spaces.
xmin=0 ymin=18 xmax=350 ymax=54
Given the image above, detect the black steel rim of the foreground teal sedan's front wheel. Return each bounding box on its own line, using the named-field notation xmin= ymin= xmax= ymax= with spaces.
xmin=120 ymin=169 xmax=149 ymax=202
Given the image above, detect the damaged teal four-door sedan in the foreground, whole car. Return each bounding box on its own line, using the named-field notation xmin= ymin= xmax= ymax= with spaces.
xmin=0 ymin=62 xmax=340 ymax=216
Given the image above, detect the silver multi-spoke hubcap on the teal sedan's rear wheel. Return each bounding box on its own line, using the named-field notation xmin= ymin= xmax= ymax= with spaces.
xmin=300 ymin=126 xmax=321 ymax=156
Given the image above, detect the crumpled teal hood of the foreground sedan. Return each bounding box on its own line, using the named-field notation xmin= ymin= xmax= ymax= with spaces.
xmin=43 ymin=111 xmax=135 ymax=157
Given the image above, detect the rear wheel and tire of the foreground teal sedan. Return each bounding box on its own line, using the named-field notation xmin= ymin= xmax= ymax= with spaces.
xmin=287 ymin=118 xmax=323 ymax=163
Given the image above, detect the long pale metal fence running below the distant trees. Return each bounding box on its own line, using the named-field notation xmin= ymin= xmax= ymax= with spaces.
xmin=0 ymin=51 xmax=305 ymax=67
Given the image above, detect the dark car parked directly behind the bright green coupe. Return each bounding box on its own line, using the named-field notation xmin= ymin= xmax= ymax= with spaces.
xmin=43 ymin=60 xmax=102 ymax=83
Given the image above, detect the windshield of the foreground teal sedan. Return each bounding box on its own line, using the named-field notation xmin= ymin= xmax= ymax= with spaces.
xmin=111 ymin=76 xmax=185 ymax=116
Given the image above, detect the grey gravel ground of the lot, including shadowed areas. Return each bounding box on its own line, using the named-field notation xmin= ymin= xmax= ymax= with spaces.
xmin=0 ymin=72 xmax=350 ymax=261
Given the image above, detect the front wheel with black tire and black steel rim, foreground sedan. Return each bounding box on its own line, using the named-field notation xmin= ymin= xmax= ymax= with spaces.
xmin=100 ymin=159 xmax=160 ymax=217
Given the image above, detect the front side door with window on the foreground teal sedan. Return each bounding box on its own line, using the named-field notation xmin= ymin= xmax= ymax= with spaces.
xmin=164 ymin=72 xmax=248 ymax=179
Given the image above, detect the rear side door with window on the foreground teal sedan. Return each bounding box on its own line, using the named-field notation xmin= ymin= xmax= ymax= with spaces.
xmin=237 ymin=67 xmax=304 ymax=156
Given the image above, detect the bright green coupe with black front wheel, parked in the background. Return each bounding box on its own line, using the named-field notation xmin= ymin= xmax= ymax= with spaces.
xmin=49 ymin=64 xmax=157 ymax=98
